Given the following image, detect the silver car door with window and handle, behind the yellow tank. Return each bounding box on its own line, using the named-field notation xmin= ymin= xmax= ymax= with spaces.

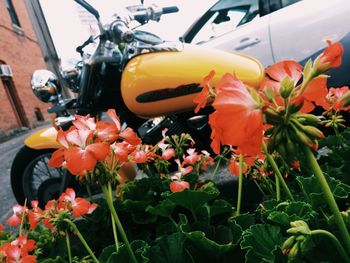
xmin=186 ymin=0 xmax=273 ymax=66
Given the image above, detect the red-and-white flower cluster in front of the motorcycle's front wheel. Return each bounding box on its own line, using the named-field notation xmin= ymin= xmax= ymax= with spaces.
xmin=49 ymin=110 xmax=142 ymax=184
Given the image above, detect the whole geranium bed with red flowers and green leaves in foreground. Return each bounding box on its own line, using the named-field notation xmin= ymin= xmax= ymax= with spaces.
xmin=0 ymin=41 xmax=350 ymax=262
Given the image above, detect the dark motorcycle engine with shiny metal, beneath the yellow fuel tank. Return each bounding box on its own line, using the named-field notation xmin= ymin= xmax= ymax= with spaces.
xmin=138 ymin=116 xmax=185 ymax=145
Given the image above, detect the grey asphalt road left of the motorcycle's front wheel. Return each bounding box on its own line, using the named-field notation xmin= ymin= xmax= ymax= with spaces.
xmin=0 ymin=127 xmax=50 ymax=224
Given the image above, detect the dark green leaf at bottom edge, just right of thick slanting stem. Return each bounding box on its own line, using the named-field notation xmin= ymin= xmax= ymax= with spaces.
xmin=149 ymin=232 xmax=193 ymax=263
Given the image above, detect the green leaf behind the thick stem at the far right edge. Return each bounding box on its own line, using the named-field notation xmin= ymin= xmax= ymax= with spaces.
xmin=297 ymin=175 xmax=350 ymax=208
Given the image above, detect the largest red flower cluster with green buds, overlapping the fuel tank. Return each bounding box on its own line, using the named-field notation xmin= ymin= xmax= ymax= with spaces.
xmin=194 ymin=41 xmax=349 ymax=163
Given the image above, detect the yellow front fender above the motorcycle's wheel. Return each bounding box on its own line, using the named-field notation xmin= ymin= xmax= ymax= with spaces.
xmin=24 ymin=127 xmax=60 ymax=150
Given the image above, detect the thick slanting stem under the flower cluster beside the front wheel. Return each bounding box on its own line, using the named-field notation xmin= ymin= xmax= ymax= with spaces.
xmin=101 ymin=183 xmax=137 ymax=263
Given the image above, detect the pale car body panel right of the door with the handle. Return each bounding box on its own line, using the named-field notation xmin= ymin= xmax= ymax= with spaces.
xmin=270 ymin=0 xmax=350 ymax=85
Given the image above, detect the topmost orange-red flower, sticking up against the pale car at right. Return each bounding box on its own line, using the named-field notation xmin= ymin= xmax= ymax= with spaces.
xmin=315 ymin=40 xmax=344 ymax=72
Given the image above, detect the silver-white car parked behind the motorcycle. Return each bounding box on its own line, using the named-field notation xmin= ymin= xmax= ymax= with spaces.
xmin=182 ymin=0 xmax=350 ymax=86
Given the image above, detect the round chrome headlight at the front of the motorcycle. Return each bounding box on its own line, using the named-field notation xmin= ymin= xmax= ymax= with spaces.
xmin=31 ymin=69 xmax=61 ymax=102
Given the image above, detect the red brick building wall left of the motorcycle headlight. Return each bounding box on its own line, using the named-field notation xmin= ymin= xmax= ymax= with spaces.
xmin=0 ymin=0 xmax=50 ymax=132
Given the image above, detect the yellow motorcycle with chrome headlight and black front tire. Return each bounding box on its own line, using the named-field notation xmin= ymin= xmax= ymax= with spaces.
xmin=11 ymin=0 xmax=264 ymax=207
